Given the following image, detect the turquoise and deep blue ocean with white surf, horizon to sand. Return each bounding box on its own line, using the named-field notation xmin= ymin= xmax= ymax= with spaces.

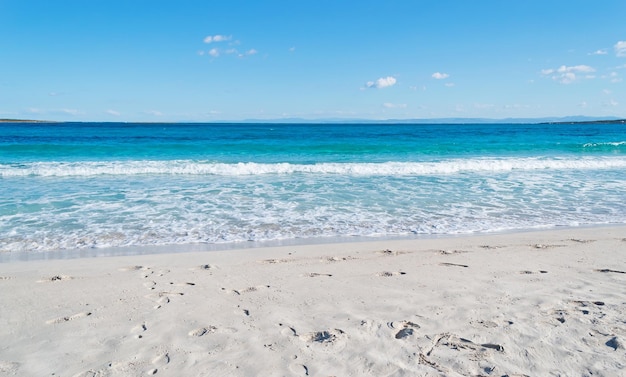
xmin=0 ymin=123 xmax=626 ymax=253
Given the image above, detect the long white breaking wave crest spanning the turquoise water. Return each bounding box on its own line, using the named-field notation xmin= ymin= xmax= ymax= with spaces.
xmin=0 ymin=157 xmax=626 ymax=178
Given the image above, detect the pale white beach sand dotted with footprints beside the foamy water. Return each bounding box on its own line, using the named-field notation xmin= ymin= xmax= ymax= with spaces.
xmin=0 ymin=227 xmax=626 ymax=377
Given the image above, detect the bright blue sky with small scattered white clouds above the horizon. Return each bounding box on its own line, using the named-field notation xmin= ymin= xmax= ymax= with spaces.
xmin=0 ymin=0 xmax=626 ymax=121
